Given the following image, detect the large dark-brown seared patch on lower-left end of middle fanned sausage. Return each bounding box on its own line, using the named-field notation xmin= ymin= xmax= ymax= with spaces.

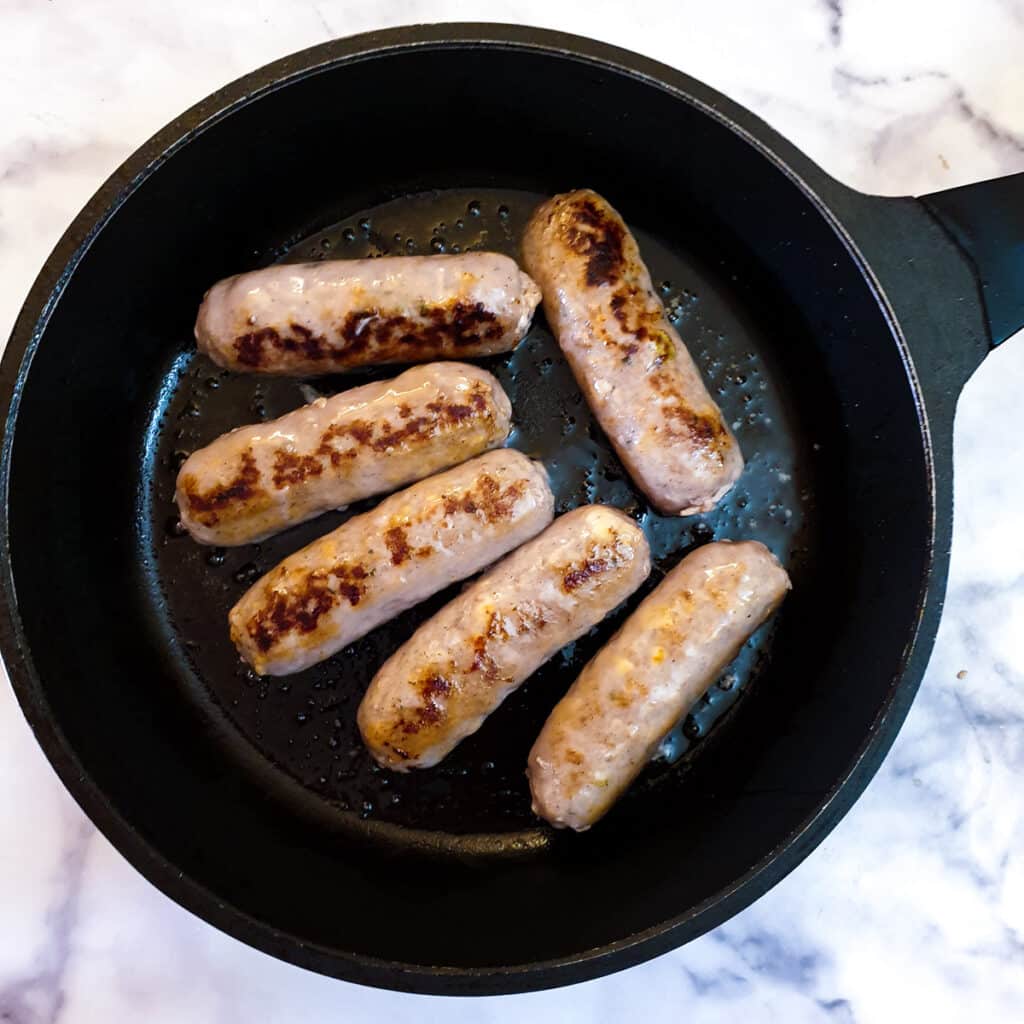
xmin=246 ymin=562 xmax=370 ymax=653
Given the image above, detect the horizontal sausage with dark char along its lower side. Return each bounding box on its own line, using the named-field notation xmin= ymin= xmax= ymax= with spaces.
xmin=196 ymin=252 xmax=541 ymax=377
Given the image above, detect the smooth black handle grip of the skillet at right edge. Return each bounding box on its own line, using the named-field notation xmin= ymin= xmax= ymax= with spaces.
xmin=920 ymin=173 xmax=1024 ymax=347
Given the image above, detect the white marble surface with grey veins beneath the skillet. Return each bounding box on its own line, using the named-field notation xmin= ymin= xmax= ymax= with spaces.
xmin=0 ymin=0 xmax=1024 ymax=1024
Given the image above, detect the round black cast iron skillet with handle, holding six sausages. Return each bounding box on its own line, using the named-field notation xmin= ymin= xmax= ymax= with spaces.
xmin=0 ymin=25 xmax=1024 ymax=993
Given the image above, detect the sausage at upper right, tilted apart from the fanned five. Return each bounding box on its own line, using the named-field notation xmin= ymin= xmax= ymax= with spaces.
xmin=522 ymin=189 xmax=743 ymax=515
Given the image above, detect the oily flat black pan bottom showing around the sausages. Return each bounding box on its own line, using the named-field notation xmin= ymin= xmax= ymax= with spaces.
xmin=135 ymin=188 xmax=823 ymax=849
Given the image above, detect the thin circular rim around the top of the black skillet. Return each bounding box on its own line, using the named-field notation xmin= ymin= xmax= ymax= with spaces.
xmin=0 ymin=23 xmax=946 ymax=995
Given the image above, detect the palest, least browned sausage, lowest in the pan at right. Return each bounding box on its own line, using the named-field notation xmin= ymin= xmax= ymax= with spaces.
xmin=526 ymin=541 xmax=790 ymax=831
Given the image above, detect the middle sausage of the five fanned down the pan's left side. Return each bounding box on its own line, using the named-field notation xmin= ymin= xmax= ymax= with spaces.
xmin=228 ymin=449 xmax=554 ymax=676
